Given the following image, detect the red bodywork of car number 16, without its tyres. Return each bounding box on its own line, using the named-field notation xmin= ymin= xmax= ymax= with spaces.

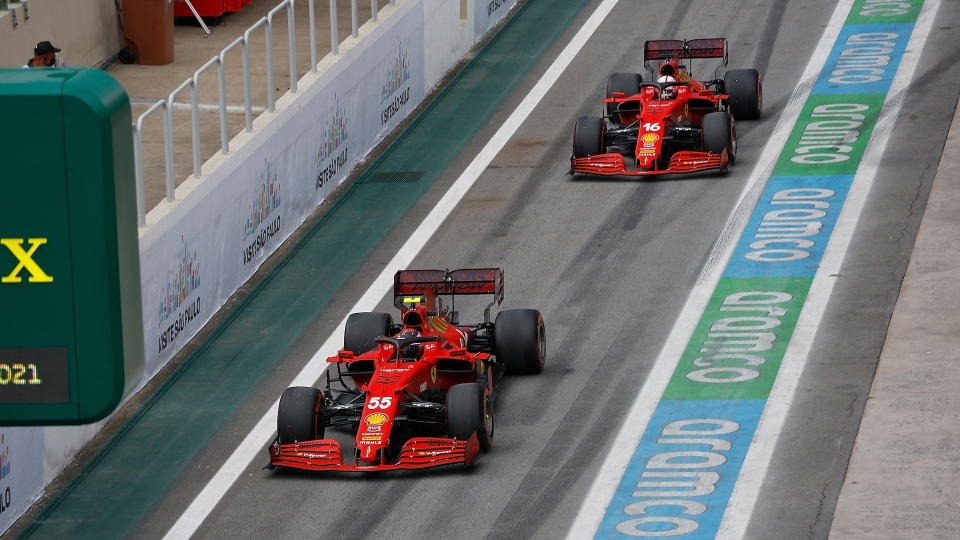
xmin=570 ymin=38 xmax=732 ymax=176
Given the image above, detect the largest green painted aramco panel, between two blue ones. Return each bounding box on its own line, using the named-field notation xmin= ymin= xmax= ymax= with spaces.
xmin=661 ymin=277 xmax=813 ymax=401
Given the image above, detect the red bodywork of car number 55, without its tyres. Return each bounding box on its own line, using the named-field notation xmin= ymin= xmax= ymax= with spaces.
xmin=270 ymin=268 xmax=503 ymax=471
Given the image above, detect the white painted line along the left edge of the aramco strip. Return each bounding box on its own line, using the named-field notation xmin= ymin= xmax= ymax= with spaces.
xmin=567 ymin=0 xmax=853 ymax=540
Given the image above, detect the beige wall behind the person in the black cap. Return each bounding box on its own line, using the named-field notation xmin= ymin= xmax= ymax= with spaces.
xmin=0 ymin=0 xmax=123 ymax=67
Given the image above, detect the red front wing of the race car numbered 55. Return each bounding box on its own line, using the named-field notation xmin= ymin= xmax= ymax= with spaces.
xmin=268 ymin=433 xmax=480 ymax=472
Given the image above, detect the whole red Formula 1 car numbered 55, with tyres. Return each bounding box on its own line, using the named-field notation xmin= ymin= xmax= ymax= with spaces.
xmin=268 ymin=268 xmax=546 ymax=471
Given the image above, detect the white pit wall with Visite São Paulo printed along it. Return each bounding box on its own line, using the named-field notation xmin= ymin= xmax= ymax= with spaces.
xmin=0 ymin=0 xmax=516 ymax=532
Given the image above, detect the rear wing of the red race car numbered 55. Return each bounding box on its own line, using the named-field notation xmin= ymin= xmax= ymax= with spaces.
xmin=393 ymin=268 xmax=503 ymax=322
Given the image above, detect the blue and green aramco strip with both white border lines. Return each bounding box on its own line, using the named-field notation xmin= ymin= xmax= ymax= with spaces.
xmin=568 ymin=0 xmax=939 ymax=538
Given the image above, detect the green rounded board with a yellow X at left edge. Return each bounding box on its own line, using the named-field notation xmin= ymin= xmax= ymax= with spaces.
xmin=0 ymin=68 xmax=144 ymax=426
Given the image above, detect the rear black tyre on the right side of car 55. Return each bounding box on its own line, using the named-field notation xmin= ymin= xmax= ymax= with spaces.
xmin=493 ymin=309 xmax=547 ymax=375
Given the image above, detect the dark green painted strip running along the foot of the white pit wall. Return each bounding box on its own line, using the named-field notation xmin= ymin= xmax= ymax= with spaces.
xmin=20 ymin=0 xmax=588 ymax=539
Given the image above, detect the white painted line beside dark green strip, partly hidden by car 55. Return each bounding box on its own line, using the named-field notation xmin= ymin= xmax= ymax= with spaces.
xmin=164 ymin=0 xmax=619 ymax=540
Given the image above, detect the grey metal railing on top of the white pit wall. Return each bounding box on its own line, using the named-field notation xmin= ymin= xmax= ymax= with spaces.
xmin=133 ymin=0 xmax=396 ymax=227
